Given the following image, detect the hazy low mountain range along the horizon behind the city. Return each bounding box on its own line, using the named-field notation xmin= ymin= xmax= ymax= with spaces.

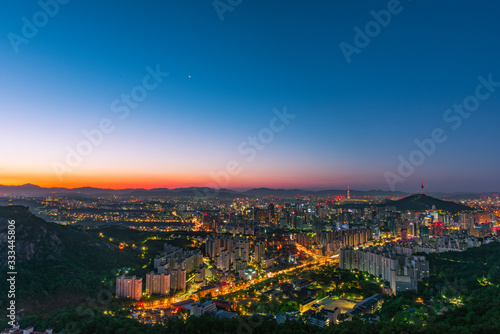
xmin=0 ymin=184 xmax=494 ymax=200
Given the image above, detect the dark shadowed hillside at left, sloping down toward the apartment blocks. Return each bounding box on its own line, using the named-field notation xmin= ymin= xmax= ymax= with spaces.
xmin=0 ymin=206 xmax=138 ymax=313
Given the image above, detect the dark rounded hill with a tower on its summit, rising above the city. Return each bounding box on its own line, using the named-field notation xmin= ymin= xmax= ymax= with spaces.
xmin=387 ymin=194 xmax=474 ymax=214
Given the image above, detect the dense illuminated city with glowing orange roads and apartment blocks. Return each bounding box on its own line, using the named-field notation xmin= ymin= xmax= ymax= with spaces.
xmin=0 ymin=187 xmax=500 ymax=333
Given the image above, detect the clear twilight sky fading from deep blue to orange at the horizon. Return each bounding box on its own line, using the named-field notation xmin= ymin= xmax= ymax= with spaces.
xmin=0 ymin=0 xmax=500 ymax=192
